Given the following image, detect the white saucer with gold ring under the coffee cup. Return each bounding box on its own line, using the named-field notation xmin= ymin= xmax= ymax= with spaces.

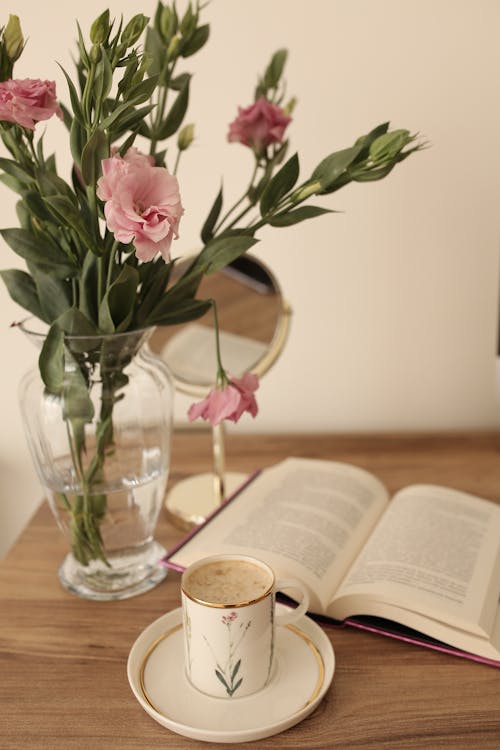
xmin=127 ymin=604 xmax=335 ymax=742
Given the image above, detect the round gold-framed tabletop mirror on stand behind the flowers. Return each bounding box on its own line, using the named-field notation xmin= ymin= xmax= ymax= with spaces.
xmin=150 ymin=253 xmax=291 ymax=529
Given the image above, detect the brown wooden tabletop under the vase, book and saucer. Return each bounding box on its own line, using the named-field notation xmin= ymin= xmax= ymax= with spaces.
xmin=0 ymin=434 xmax=500 ymax=750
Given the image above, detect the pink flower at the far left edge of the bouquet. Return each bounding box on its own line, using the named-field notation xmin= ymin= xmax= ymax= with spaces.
xmin=0 ymin=78 xmax=63 ymax=130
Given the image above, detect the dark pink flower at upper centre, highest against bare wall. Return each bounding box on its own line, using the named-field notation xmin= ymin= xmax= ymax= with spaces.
xmin=227 ymin=96 xmax=292 ymax=152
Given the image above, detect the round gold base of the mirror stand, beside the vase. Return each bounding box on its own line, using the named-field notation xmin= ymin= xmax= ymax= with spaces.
xmin=165 ymin=472 xmax=247 ymax=531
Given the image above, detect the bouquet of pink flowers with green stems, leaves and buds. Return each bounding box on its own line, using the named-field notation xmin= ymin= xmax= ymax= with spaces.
xmin=0 ymin=7 xmax=421 ymax=592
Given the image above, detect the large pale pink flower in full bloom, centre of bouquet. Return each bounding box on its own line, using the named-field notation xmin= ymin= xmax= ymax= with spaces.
xmin=97 ymin=148 xmax=184 ymax=261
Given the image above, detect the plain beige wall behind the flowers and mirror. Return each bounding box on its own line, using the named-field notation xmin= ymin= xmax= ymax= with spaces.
xmin=0 ymin=0 xmax=500 ymax=554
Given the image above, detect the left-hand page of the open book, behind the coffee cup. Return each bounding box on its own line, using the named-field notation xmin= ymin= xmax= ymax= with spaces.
xmin=166 ymin=458 xmax=388 ymax=612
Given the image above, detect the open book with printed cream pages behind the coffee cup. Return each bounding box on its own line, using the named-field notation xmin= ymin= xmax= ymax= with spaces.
xmin=164 ymin=458 xmax=500 ymax=667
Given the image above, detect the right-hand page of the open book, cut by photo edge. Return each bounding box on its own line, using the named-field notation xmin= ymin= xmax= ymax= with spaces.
xmin=332 ymin=485 xmax=500 ymax=637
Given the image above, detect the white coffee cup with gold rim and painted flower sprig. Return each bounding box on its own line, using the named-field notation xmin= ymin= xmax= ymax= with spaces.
xmin=181 ymin=554 xmax=309 ymax=698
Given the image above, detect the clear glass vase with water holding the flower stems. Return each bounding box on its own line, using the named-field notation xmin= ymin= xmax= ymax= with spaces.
xmin=19 ymin=325 xmax=174 ymax=600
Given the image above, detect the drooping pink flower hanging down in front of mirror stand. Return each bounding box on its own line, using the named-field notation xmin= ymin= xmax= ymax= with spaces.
xmin=188 ymin=372 xmax=259 ymax=426
